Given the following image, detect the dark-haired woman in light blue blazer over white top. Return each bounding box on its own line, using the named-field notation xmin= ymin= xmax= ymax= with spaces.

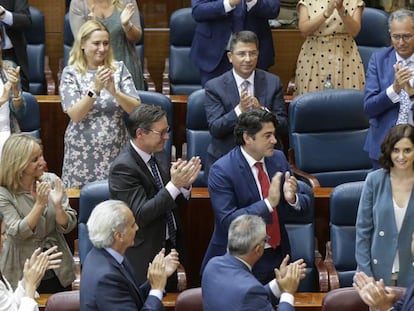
xmin=355 ymin=124 xmax=414 ymax=287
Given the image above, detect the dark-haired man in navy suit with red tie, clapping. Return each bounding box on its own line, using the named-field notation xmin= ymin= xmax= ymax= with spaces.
xmin=202 ymin=109 xmax=310 ymax=284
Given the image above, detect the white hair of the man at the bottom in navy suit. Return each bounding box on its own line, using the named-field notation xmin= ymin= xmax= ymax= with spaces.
xmin=86 ymin=200 xmax=129 ymax=248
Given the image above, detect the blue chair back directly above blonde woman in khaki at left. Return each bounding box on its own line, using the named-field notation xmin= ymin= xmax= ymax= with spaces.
xmin=19 ymin=92 xmax=40 ymax=139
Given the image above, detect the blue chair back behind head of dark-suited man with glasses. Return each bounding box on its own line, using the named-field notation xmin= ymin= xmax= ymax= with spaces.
xmin=138 ymin=91 xmax=175 ymax=159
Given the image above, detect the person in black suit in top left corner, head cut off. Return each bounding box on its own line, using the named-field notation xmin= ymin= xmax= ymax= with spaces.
xmin=0 ymin=0 xmax=32 ymax=92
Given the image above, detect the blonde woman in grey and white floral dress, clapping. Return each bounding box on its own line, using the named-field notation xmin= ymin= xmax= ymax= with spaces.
xmin=60 ymin=20 xmax=141 ymax=188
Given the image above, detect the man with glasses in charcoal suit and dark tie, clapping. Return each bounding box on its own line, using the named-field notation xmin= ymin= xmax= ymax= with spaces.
xmin=109 ymin=104 xmax=201 ymax=288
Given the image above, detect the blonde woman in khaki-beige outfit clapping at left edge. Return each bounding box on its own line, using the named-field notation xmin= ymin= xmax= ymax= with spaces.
xmin=0 ymin=134 xmax=76 ymax=293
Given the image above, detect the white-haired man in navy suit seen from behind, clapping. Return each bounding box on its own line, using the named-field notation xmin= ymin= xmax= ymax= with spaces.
xmin=80 ymin=200 xmax=179 ymax=311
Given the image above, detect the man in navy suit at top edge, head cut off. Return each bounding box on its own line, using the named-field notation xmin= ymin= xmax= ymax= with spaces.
xmin=190 ymin=0 xmax=280 ymax=87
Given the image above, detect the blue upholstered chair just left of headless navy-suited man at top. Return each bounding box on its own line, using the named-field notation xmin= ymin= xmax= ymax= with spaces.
xmin=162 ymin=8 xmax=201 ymax=95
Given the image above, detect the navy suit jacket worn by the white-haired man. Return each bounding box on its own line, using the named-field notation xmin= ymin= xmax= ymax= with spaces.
xmin=80 ymin=247 xmax=164 ymax=311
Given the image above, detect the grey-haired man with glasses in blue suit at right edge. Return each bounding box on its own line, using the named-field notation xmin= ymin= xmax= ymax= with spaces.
xmin=364 ymin=9 xmax=414 ymax=168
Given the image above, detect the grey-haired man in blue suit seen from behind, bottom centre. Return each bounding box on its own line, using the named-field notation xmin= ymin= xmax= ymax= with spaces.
xmin=201 ymin=215 xmax=301 ymax=311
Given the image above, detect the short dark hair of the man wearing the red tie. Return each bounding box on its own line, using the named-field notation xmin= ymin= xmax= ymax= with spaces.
xmin=234 ymin=109 xmax=277 ymax=146
